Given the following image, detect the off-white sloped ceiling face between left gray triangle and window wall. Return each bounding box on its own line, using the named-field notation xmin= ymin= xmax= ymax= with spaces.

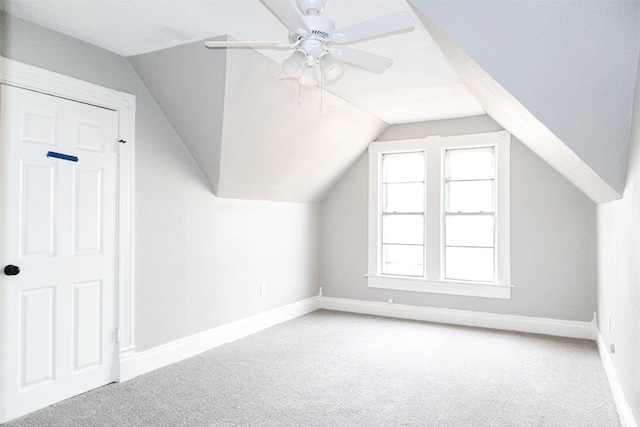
xmin=218 ymin=49 xmax=387 ymax=202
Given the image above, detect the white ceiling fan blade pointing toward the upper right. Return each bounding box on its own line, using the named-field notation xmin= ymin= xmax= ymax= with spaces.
xmin=331 ymin=10 xmax=415 ymax=43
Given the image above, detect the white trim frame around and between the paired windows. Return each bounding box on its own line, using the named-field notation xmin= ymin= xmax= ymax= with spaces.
xmin=366 ymin=131 xmax=513 ymax=299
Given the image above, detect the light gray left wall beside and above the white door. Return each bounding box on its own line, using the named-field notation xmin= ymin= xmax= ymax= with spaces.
xmin=0 ymin=14 xmax=319 ymax=350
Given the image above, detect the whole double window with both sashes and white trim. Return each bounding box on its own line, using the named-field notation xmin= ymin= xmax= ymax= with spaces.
xmin=367 ymin=131 xmax=512 ymax=298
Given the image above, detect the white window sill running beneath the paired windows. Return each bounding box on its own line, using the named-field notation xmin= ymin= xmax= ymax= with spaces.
xmin=366 ymin=274 xmax=513 ymax=299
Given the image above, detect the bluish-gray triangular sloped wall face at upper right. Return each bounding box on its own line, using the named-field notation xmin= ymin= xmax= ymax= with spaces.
xmin=411 ymin=0 xmax=640 ymax=191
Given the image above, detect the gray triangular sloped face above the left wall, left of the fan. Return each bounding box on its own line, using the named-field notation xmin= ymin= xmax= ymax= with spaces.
xmin=129 ymin=37 xmax=226 ymax=189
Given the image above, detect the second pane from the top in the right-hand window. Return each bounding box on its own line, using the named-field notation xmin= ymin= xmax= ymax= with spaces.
xmin=445 ymin=180 xmax=494 ymax=212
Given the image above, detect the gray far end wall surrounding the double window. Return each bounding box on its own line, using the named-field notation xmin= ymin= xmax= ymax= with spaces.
xmin=320 ymin=117 xmax=596 ymax=321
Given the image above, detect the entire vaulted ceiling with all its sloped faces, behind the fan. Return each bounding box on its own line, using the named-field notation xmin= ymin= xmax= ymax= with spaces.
xmin=0 ymin=0 xmax=640 ymax=202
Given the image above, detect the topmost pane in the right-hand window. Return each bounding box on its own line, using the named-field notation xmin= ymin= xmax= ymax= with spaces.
xmin=445 ymin=147 xmax=495 ymax=180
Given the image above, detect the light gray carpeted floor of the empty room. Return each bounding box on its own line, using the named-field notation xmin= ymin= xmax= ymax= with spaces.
xmin=6 ymin=311 xmax=620 ymax=427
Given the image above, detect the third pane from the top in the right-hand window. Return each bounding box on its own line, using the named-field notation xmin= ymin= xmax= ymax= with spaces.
xmin=445 ymin=215 xmax=494 ymax=247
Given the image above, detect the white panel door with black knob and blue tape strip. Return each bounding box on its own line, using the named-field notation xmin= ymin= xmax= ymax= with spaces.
xmin=0 ymin=84 xmax=118 ymax=421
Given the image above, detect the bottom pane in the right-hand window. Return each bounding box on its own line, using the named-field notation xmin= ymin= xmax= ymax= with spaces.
xmin=445 ymin=247 xmax=494 ymax=282
